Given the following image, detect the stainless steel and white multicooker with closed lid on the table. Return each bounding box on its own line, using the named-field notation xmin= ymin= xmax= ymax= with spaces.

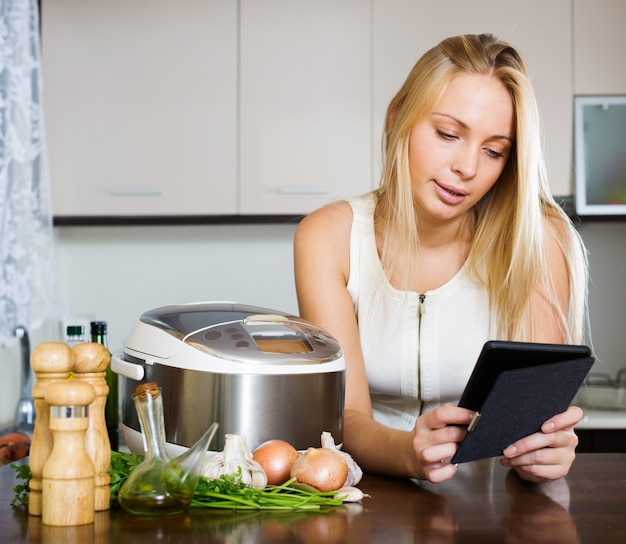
xmin=111 ymin=302 xmax=345 ymax=453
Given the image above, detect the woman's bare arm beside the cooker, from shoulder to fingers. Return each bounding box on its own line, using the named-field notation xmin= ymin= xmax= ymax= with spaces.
xmin=294 ymin=202 xmax=473 ymax=482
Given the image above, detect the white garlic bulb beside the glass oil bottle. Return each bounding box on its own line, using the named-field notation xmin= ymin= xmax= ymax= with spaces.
xmin=203 ymin=434 xmax=267 ymax=489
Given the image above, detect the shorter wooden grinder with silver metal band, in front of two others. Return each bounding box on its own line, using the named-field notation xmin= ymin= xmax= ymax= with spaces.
xmin=41 ymin=380 xmax=96 ymax=526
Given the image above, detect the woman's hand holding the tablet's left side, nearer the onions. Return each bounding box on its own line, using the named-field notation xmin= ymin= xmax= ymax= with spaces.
xmin=412 ymin=404 xmax=475 ymax=483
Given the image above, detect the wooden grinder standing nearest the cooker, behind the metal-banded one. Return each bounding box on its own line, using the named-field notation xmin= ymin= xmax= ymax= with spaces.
xmin=71 ymin=342 xmax=111 ymax=512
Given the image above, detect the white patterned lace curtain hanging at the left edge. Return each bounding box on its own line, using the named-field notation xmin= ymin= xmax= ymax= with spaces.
xmin=0 ymin=0 xmax=63 ymax=345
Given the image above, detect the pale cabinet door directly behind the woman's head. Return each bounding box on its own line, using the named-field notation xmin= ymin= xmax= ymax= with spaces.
xmin=373 ymin=0 xmax=572 ymax=195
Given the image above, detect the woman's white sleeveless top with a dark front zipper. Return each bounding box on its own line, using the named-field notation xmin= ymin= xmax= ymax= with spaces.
xmin=347 ymin=193 xmax=492 ymax=430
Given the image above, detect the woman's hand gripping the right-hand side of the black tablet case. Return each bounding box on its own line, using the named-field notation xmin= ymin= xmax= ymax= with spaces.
xmin=500 ymin=406 xmax=583 ymax=482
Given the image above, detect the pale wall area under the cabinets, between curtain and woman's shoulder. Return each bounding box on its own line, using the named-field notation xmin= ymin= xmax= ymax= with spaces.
xmin=56 ymin=224 xmax=297 ymax=351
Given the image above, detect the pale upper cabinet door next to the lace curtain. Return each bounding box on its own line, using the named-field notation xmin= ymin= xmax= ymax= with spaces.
xmin=42 ymin=0 xmax=237 ymax=217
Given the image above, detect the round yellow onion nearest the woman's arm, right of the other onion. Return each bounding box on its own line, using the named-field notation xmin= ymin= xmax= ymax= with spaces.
xmin=291 ymin=448 xmax=348 ymax=492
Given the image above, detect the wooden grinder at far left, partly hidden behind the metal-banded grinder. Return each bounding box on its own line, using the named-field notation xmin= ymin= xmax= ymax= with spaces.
xmin=28 ymin=342 xmax=72 ymax=516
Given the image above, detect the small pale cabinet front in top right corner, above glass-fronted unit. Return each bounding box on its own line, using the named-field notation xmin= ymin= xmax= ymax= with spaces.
xmin=573 ymin=0 xmax=626 ymax=95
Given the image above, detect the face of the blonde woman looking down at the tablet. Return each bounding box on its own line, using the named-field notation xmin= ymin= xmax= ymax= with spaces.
xmin=409 ymin=74 xmax=515 ymax=221
